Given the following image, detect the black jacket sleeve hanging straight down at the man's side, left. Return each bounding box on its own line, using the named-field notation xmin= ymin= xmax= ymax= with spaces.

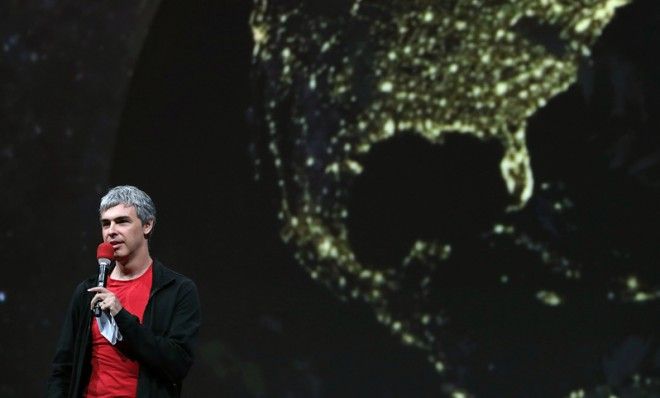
xmin=46 ymin=284 xmax=84 ymax=398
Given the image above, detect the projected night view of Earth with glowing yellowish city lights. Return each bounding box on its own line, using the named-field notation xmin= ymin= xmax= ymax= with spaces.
xmin=250 ymin=0 xmax=660 ymax=397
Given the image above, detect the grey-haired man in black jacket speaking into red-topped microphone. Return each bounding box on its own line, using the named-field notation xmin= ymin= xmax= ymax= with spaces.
xmin=47 ymin=186 xmax=200 ymax=398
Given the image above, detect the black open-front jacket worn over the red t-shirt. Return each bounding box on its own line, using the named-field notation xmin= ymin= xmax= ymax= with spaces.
xmin=46 ymin=260 xmax=201 ymax=398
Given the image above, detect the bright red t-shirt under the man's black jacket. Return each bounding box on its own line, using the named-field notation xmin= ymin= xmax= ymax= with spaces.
xmin=85 ymin=265 xmax=152 ymax=398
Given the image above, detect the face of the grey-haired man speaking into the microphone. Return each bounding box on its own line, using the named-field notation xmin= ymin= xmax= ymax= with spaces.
xmin=101 ymin=204 xmax=153 ymax=258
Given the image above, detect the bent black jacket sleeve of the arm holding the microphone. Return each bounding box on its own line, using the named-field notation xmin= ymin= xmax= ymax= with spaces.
xmin=115 ymin=280 xmax=201 ymax=383
